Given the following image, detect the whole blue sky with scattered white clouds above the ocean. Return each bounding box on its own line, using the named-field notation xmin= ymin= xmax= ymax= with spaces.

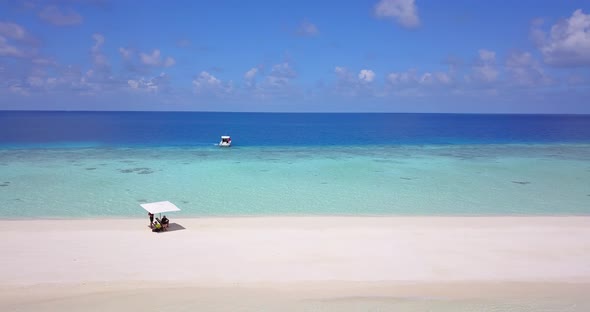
xmin=0 ymin=0 xmax=590 ymax=114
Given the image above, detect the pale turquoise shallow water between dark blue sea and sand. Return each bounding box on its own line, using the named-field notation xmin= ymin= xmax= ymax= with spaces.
xmin=0 ymin=144 xmax=590 ymax=218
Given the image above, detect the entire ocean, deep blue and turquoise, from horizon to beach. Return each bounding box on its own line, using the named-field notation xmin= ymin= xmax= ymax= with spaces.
xmin=0 ymin=111 xmax=590 ymax=219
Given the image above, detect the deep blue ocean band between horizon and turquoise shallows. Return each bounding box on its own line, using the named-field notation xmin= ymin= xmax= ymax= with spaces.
xmin=0 ymin=111 xmax=590 ymax=147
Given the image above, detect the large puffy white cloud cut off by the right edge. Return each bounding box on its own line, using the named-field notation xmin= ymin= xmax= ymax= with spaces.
xmin=532 ymin=10 xmax=590 ymax=66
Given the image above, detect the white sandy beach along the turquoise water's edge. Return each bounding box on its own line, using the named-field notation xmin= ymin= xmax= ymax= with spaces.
xmin=0 ymin=215 xmax=590 ymax=311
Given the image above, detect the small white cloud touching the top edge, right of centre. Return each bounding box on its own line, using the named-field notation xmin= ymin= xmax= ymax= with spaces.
xmin=375 ymin=0 xmax=420 ymax=28
